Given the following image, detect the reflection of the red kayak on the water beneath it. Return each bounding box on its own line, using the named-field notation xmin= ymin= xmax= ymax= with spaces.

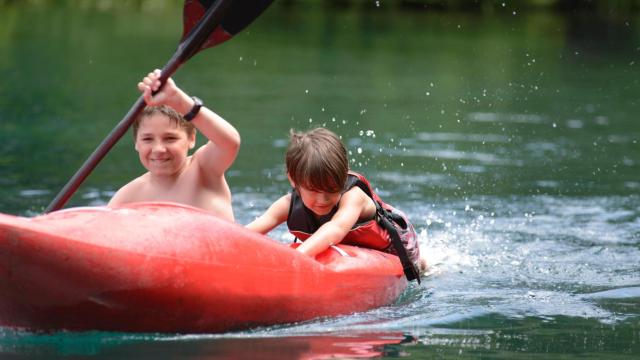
xmin=0 ymin=330 xmax=410 ymax=360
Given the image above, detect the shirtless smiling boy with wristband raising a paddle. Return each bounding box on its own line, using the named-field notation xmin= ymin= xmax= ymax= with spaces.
xmin=109 ymin=69 xmax=240 ymax=221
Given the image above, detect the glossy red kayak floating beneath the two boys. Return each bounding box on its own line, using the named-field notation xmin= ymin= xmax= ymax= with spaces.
xmin=0 ymin=203 xmax=407 ymax=333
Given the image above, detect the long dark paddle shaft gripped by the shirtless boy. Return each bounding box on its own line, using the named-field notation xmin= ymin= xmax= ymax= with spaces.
xmin=45 ymin=0 xmax=232 ymax=213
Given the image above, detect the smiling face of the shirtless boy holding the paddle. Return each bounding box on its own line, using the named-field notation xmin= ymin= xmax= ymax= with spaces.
xmin=135 ymin=114 xmax=196 ymax=176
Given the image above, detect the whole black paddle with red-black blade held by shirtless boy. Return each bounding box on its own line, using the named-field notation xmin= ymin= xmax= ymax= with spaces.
xmin=45 ymin=0 xmax=273 ymax=213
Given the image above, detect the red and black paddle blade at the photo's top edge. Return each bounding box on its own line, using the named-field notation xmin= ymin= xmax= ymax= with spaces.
xmin=181 ymin=0 xmax=273 ymax=51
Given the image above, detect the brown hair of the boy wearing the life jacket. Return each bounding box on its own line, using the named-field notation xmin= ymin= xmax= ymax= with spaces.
xmin=285 ymin=128 xmax=349 ymax=193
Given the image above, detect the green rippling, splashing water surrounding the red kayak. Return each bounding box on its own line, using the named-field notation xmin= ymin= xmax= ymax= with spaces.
xmin=0 ymin=1 xmax=640 ymax=359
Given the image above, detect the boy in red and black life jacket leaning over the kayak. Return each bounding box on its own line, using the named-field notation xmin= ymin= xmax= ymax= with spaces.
xmin=247 ymin=128 xmax=426 ymax=281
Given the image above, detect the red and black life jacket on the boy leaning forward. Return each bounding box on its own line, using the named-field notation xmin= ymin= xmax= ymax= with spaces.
xmin=287 ymin=171 xmax=420 ymax=282
